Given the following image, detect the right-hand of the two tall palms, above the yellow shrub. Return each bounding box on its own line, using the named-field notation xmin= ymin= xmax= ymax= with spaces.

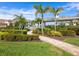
xmin=49 ymin=7 xmax=63 ymax=31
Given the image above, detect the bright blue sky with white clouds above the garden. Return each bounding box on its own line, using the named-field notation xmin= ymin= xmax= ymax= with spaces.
xmin=0 ymin=2 xmax=79 ymax=20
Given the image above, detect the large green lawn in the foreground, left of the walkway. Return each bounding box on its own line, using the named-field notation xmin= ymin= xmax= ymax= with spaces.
xmin=0 ymin=42 xmax=71 ymax=56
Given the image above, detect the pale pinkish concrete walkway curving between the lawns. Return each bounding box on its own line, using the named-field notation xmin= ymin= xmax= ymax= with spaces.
xmin=28 ymin=31 xmax=79 ymax=56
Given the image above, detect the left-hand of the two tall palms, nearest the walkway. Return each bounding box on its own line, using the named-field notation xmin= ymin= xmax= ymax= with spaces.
xmin=33 ymin=5 xmax=49 ymax=35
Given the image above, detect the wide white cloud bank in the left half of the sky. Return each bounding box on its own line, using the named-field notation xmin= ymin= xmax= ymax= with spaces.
xmin=0 ymin=7 xmax=36 ymax=20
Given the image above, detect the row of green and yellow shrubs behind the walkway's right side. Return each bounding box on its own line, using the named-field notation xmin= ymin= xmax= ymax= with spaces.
xmin=33 ymin=29 xmax=76 ymax=37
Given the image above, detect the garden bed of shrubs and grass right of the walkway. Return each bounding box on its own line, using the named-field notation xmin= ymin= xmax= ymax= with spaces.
xmin=33 ymin=26 xmax=79 ymax=46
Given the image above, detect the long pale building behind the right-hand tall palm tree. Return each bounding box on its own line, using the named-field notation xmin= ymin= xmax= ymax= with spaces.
xmin=44 ymin=16 xmax=79 ymax=26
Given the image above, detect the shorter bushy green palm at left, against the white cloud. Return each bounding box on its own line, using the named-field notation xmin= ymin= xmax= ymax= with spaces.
xmin=15 ymin=15 xmax=27 ymax=29
